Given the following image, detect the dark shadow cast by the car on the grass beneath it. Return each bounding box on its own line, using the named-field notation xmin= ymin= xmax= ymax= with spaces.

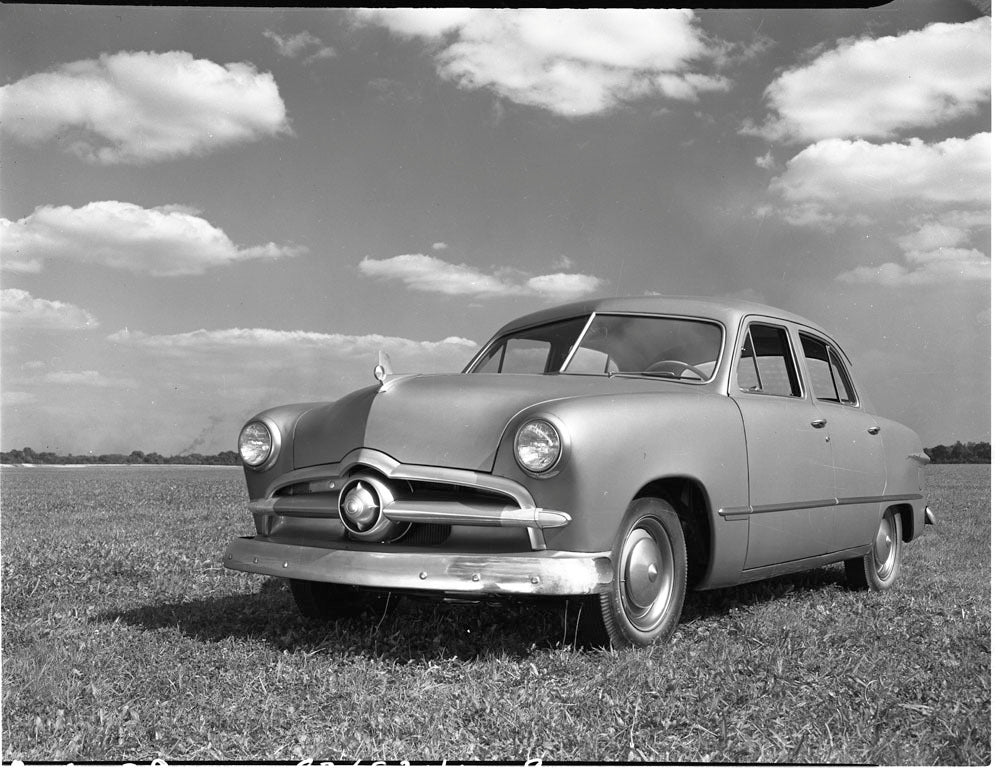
xmin=98 ymin=567 xmax=843 ymax=663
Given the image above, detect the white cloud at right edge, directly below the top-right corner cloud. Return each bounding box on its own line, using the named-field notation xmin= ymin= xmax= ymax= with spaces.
xmin=770 ymin=133 xmax=990 ymax=214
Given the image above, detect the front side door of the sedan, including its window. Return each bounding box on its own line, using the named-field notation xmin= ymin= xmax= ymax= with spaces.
xmin=730 ymin=318 xmax=836 ymax=569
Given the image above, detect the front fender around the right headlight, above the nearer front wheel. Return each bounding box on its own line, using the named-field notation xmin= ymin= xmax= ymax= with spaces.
xmin=494 ymin=392 xmax=749 ymax=571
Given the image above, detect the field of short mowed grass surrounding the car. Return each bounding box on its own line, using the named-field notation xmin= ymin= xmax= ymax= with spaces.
xmin=0 ymin=466 xmax=991 ymax=765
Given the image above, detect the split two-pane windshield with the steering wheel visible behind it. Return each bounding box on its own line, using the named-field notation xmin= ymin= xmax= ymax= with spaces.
xmin=468 ymin=314 xmax=722 ymax=382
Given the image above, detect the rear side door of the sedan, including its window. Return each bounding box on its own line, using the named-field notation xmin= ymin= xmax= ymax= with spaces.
xmin=799 ymin=331 xmax=885 ymax=552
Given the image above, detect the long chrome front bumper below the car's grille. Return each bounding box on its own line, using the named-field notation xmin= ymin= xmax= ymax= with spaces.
xmin=223 ymin=536 xmax=612 ymax=596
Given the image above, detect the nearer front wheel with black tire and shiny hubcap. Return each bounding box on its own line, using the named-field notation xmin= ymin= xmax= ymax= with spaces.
xmin=600 ymin=498 xmax=687 ymax=648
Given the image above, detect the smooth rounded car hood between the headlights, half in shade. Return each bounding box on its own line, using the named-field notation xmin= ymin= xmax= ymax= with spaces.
xmin=292 ymin=374 xmax=687 ymax=471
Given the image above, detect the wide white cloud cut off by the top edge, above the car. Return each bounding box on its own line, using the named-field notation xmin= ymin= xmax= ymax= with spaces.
xmin=355 ymin=8 xmax=730 ymax=116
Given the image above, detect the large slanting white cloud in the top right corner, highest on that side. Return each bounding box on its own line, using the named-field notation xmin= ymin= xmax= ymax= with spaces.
xmin=747 ymin=16 xmax=991 ymax=141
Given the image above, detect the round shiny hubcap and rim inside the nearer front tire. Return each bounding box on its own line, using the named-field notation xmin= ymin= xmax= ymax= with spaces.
xmin=618 ymin=517 xmax=674 ymax=631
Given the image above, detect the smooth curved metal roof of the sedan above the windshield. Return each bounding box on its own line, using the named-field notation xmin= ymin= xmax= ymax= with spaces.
xmin=498 ymin=295 xmax=826 ymax=335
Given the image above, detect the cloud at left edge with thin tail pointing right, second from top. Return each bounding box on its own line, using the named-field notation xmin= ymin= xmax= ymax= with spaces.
xmin=0 ymin=201 xmax=306 ymax=276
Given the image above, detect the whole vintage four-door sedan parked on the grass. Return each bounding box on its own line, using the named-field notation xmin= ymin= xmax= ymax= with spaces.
xmin=225 ymin=297 xmax=934 ymax=647
